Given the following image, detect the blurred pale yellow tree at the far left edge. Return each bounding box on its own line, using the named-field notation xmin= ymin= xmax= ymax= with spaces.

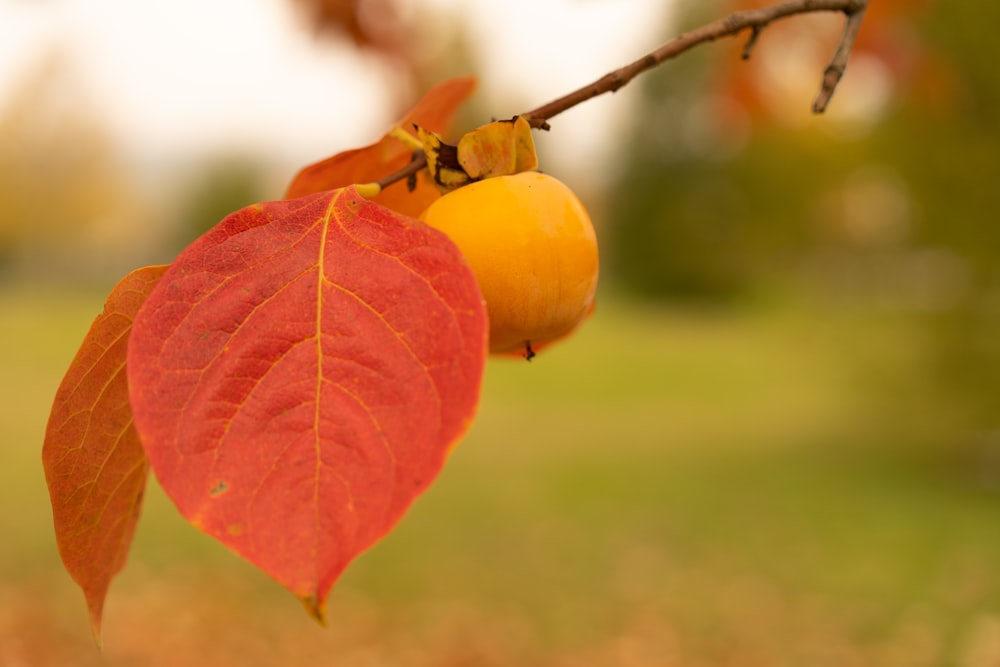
xmin=0 ymin=53 xmax=147 ymax=275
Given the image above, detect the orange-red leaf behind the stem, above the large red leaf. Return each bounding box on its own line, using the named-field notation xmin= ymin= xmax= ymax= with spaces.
xmin=285 ymin=77 xmax=476 ymax=217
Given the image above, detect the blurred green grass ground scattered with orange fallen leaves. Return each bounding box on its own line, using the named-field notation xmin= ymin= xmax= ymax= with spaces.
xmin=0 ymin=286 xmax=1000 ymax=667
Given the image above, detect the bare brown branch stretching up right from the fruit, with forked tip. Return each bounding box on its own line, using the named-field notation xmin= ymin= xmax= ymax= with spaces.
xmin=521 ymin=0 xmax=868 ymax=130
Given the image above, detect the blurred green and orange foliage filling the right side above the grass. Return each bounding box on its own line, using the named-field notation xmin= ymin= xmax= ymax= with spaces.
xmin=606 ymin=2 xmax=1000 ymax=444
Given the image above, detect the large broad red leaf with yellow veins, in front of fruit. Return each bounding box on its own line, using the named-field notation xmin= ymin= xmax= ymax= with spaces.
xmin=128 ymin=187 xmax=487 ymax=619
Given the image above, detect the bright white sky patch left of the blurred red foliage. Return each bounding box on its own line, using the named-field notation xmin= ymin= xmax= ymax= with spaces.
xmin=0 ymin=0 xmax=402 ymax=166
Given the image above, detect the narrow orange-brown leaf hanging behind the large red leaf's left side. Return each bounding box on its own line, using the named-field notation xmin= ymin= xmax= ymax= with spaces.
xmin=42 ymin=266 xmax=167 ymax=643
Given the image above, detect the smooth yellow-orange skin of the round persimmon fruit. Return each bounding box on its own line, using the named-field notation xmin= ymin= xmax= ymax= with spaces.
xmin=420 ymin=171 xmax=598 ymax=358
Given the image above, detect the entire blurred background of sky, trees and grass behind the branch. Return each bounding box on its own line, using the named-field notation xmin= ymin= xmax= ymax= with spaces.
xmin=0 ymin=0 xmax=1000 ymax=667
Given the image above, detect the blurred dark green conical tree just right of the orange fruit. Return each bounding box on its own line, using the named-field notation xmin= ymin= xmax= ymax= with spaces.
xmin=605 ymin=2 xmax=764 ymax=301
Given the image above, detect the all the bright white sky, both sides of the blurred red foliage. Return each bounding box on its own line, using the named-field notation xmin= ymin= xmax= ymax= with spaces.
xmin=0 ymin=0 xmax=671 ymax=175
